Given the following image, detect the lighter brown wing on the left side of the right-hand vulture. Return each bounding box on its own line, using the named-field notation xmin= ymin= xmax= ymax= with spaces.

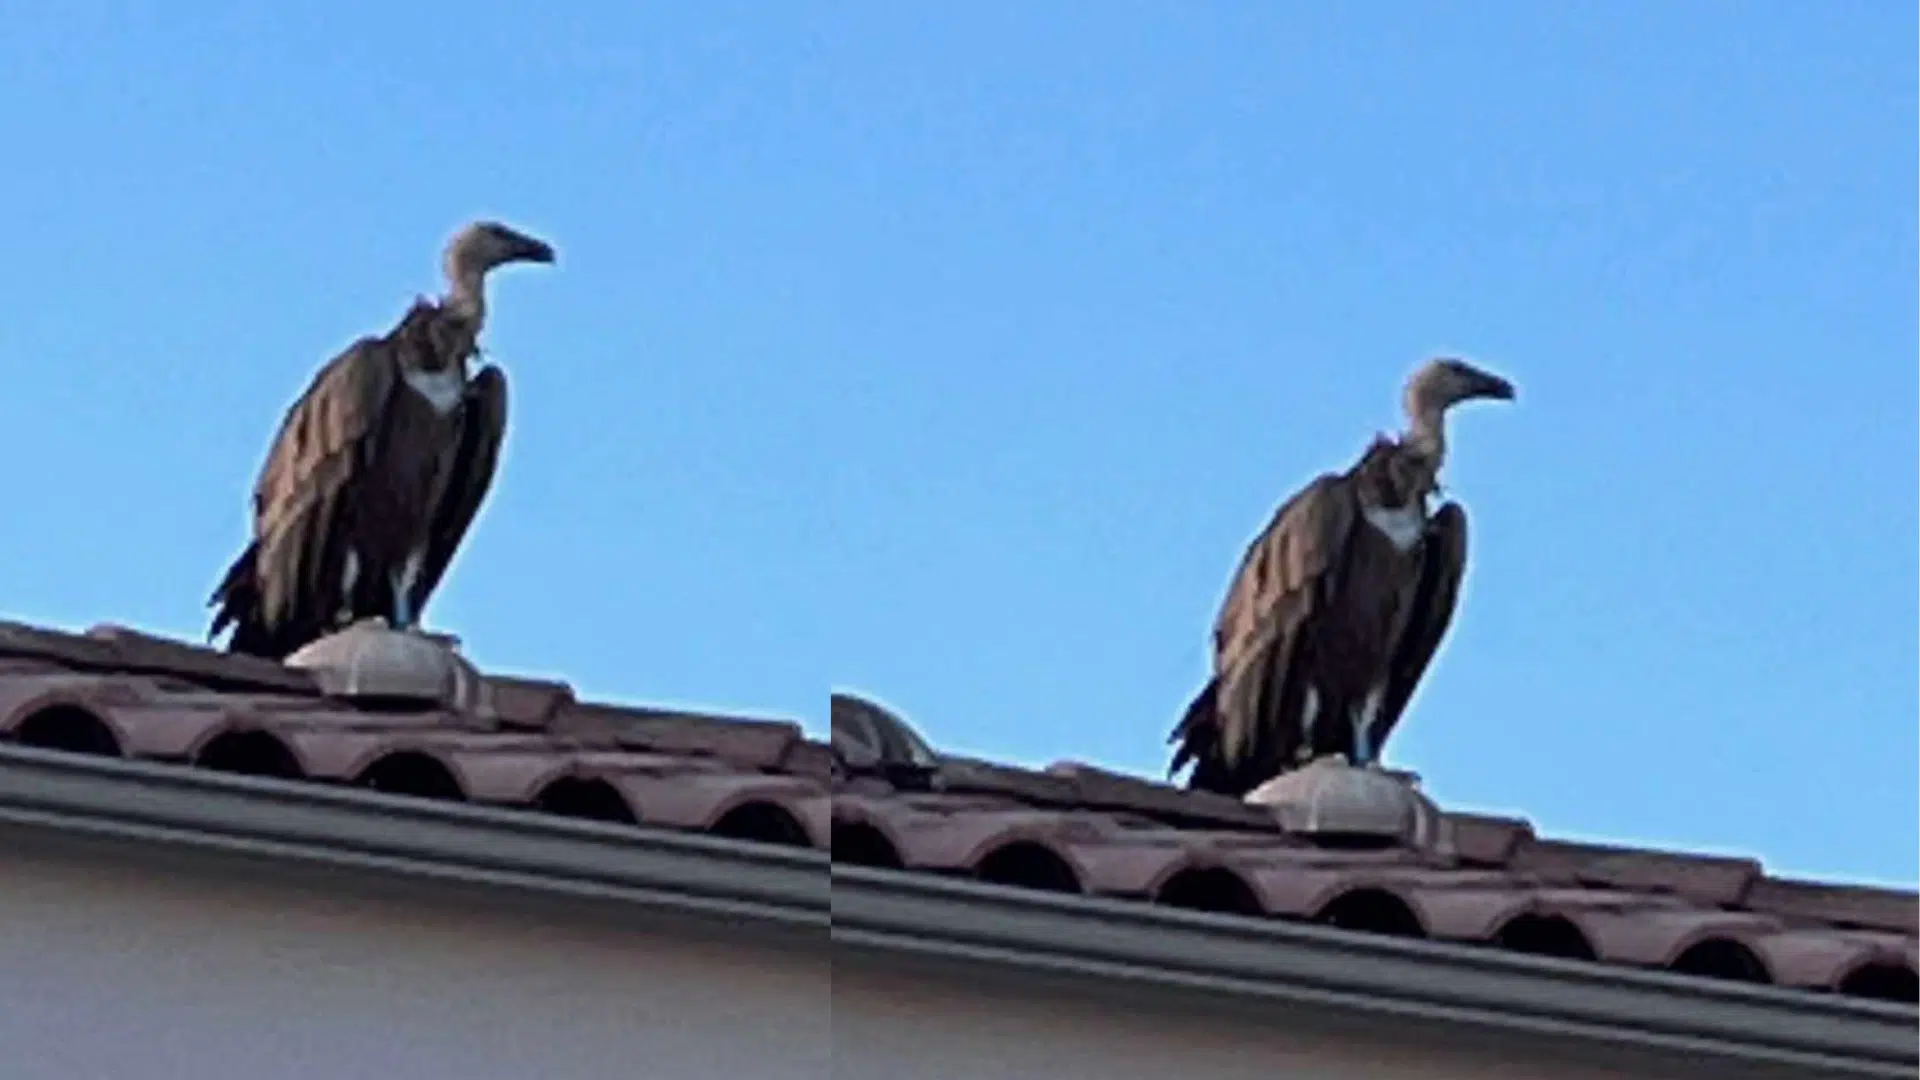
xmin=1190 ymin=473 xmax=1354 ymax=769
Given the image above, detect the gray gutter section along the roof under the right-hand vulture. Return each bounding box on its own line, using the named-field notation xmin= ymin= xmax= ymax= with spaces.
xmin=833 ymin=865 xmax=1920 ymax=1078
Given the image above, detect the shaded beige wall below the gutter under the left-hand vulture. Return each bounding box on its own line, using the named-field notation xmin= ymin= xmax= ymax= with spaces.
xmin=0 ymin=838 xmax=833 ymax=1080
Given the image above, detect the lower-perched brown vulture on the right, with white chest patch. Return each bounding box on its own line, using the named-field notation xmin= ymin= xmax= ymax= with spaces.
xmin=1167 ymin=357 xmax=1515 ymax=798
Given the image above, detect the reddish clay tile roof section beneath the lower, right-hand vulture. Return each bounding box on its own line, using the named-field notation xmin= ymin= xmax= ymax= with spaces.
xmin=833 ymin=696 xmax=1920 ymax=1001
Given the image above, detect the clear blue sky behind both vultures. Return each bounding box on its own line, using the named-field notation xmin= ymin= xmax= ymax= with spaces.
xmin=0 ymin=0 xmax=1920 ymax=886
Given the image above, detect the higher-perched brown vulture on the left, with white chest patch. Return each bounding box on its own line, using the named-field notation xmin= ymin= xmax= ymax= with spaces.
xmin=207 ymin=221 xmax=553 ymax=659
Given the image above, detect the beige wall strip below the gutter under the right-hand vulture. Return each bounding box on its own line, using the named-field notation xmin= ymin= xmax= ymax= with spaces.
xmin=833 ymin=959 xmax=1701 ymax=1080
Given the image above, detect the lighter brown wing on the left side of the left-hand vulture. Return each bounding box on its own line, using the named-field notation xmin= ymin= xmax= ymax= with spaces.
xmin=253 ymin=336 xmax=397 ymax=623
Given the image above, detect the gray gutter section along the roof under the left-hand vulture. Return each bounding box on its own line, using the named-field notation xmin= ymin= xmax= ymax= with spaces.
xmin=0 ymin=746 xmax=831 ymax=930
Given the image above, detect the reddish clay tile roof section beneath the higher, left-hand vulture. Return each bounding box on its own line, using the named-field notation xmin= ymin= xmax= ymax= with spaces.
xmin=0 ymin=623 xmax=833 ymax=849
